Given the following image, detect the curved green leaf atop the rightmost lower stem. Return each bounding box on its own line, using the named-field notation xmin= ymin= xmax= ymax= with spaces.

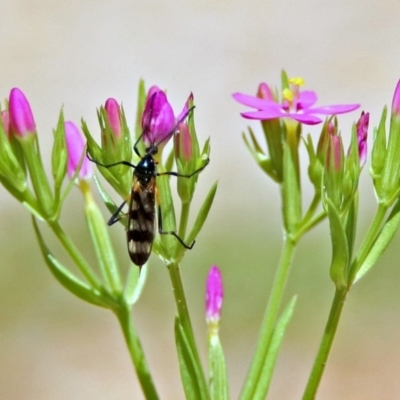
xmin=324 ymin=197 xmax=349 ymax=289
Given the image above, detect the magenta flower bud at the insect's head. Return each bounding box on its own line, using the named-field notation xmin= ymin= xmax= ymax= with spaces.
xmin=142 ymin=86 xmax=175 ymax=146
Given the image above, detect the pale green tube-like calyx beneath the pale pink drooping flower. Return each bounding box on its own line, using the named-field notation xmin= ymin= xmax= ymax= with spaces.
xmin=85 ymin=193 xmax=122 ymax=295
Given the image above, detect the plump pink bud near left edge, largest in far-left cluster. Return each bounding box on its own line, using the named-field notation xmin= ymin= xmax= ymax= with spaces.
xmin=8 ymin=88 xmax=36 ymax=137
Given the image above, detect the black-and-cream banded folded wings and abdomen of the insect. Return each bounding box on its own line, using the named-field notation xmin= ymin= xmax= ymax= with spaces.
xmin=126 ymin=177 xmax=155 ymax=267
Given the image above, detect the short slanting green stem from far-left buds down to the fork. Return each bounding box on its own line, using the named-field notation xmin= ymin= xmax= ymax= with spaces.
xmin=48 ymin=221 xmax=103 ymax=292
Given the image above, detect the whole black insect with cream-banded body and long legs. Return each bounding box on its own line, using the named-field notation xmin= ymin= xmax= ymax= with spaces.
xmin=87 ymin=99 xmax=209 ymax=268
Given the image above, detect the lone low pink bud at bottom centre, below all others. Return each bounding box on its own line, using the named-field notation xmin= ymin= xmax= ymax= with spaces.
xmin=206 ymin=265 xmax=224 ymax=323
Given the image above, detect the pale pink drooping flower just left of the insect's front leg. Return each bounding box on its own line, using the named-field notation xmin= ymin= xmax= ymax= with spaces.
xmin=64 ymin=121 xmax=92 ymax=179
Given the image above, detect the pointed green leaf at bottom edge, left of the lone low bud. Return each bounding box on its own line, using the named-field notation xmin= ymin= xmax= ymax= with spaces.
xmin=175 ymin=317 xmax=210 ymax=400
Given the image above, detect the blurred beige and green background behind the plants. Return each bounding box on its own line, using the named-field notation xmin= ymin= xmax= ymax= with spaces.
xmin=0 ymin=0 xmax=400 ymax=400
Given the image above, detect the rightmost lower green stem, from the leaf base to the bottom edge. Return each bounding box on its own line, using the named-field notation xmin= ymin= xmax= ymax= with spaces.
xmin=303 ymin=289 xmax=348 ymax=400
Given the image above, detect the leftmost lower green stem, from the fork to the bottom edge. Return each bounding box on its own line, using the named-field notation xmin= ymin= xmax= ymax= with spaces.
xmin=115 ymin=305 xmax=159 ymax=400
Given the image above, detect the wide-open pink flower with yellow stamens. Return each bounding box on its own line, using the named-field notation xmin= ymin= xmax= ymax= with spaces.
xmin=233 ymin=78 xmax=360 ymax=125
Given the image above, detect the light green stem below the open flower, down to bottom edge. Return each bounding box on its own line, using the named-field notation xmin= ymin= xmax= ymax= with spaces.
xmin=240 ymin=235 xmax=296 ymax=400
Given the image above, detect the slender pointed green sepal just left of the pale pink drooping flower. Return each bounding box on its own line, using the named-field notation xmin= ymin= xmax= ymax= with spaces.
xmin=51 ymin=109 xmax=67 ymax=208
